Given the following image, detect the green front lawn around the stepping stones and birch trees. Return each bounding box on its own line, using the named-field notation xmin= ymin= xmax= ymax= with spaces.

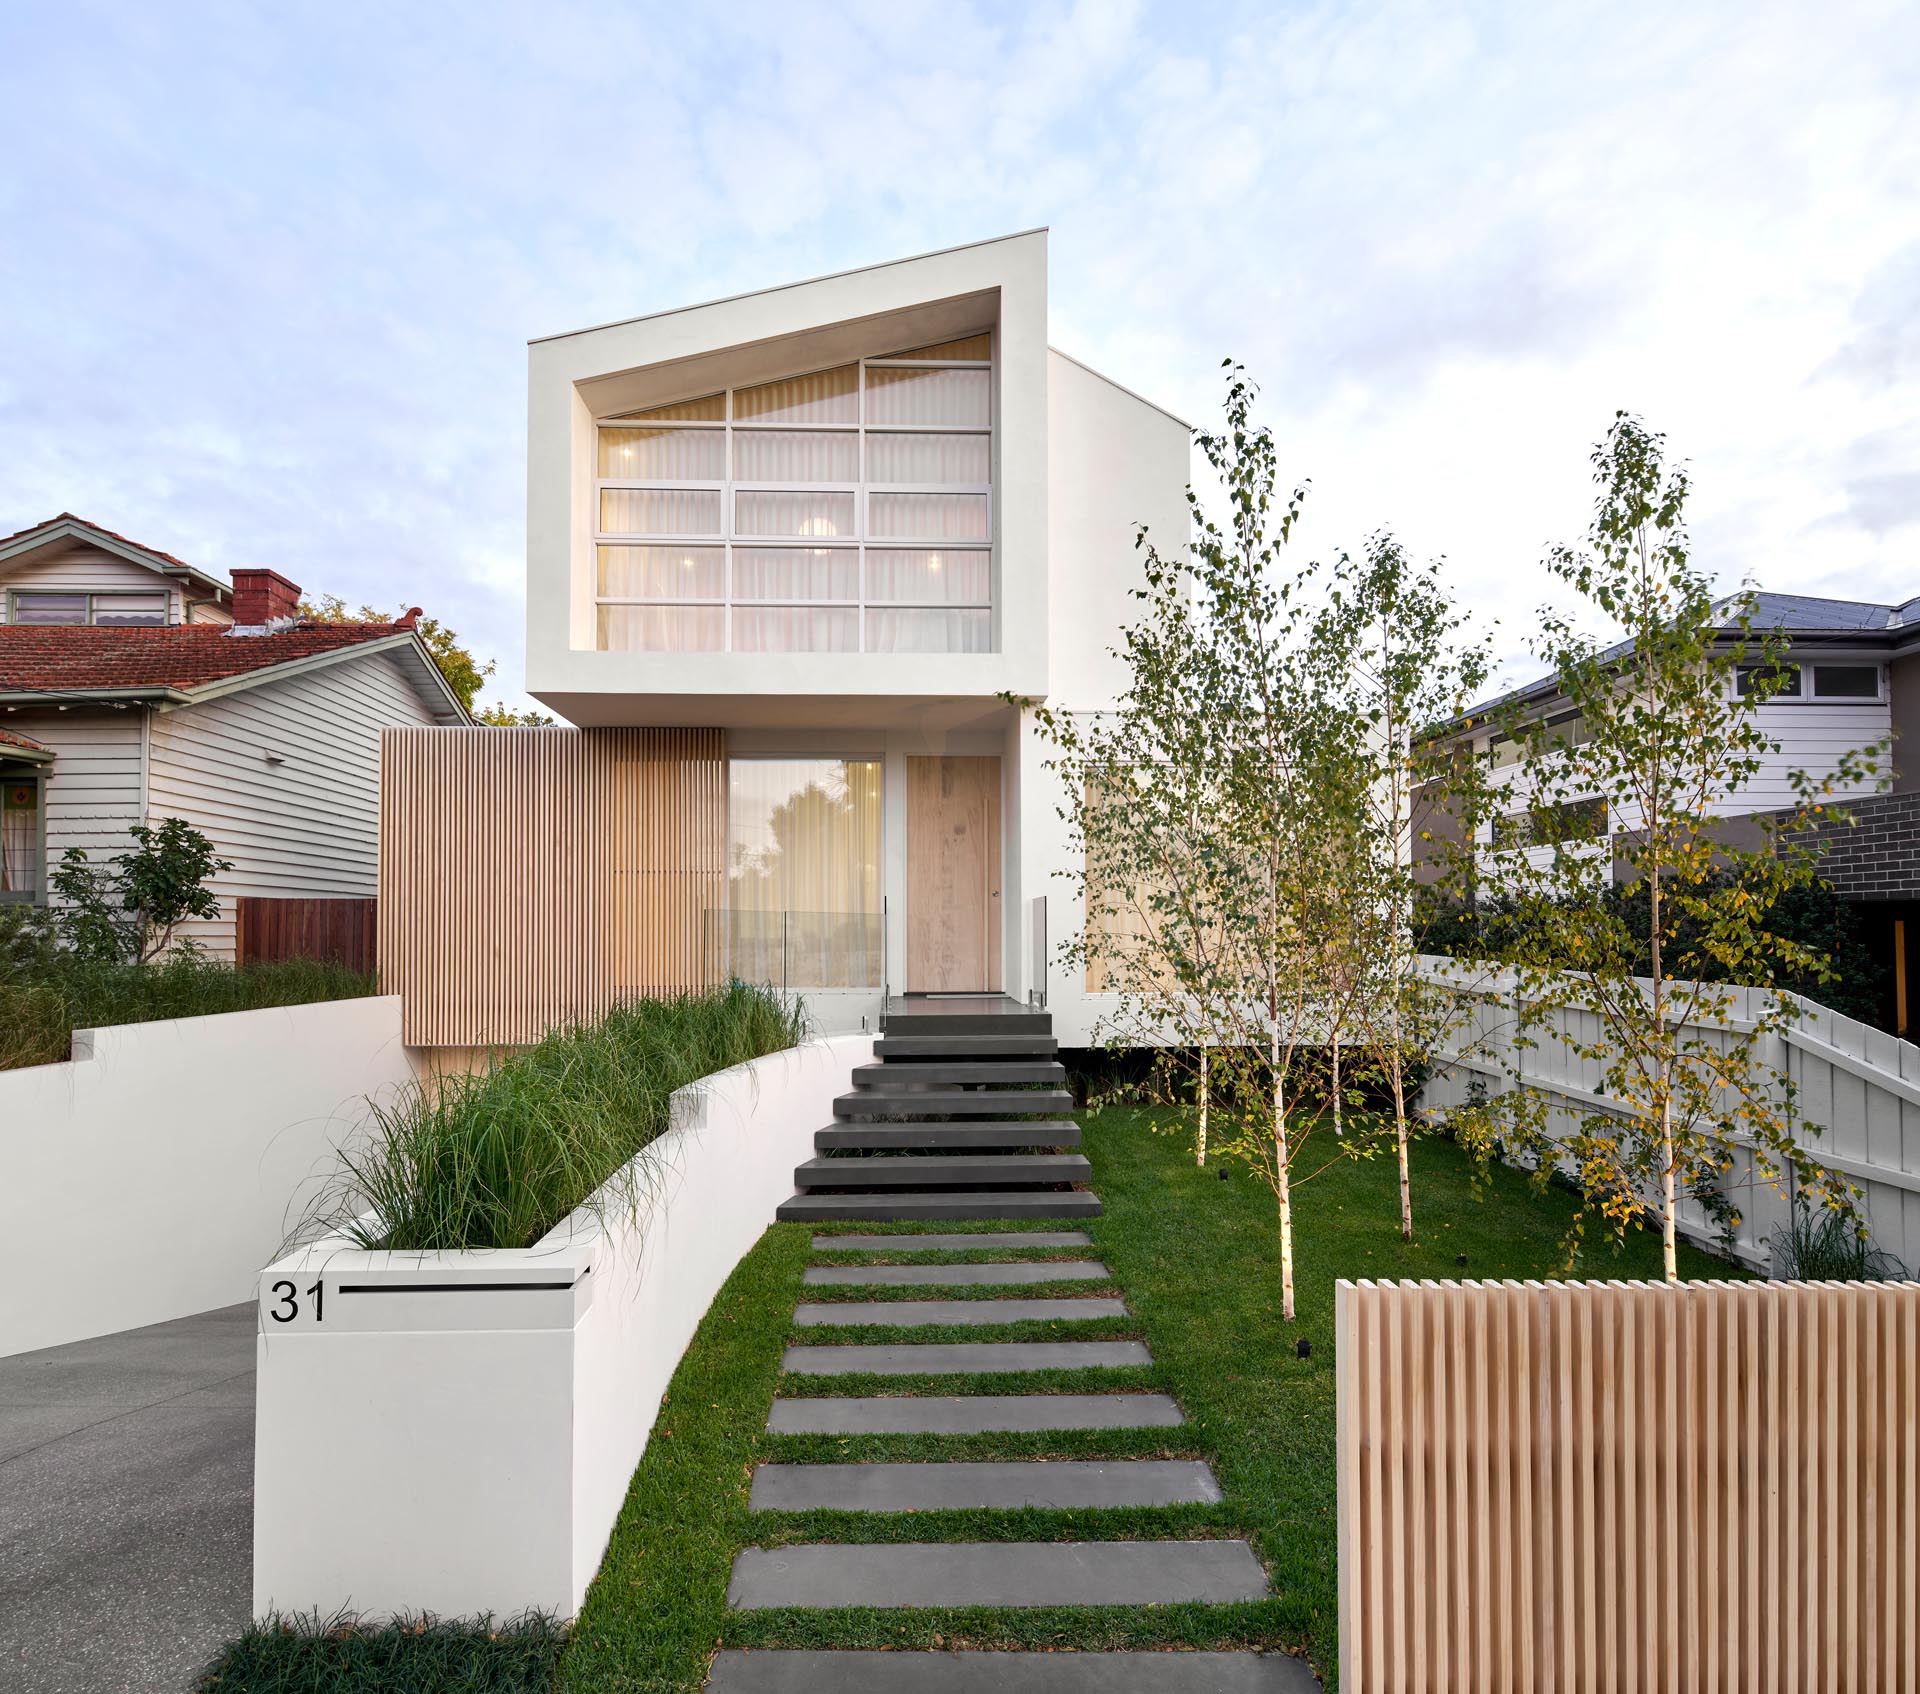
xmin=559 ymin=1112 xmax=1734 ymax=1694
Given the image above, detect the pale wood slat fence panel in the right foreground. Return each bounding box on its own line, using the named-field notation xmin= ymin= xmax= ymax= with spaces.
xmin=1336 ymin=1283 xmax=1920 ymax=1694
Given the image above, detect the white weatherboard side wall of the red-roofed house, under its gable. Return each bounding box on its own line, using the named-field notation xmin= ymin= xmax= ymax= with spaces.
xmin=148 ymin=653 xmax=434 ymax=958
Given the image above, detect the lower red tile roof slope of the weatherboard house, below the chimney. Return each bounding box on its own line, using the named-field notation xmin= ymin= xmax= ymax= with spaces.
xmin=0 ymin=624 xmax=411 ymax=693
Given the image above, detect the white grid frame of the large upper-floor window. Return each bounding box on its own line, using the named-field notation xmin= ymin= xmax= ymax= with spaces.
xmin=591 ymin=330 xmax=998 ymax=653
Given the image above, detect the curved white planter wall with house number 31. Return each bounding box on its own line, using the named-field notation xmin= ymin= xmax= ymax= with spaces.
xmin=253 ymin=1035 xmax=874 ymax=1617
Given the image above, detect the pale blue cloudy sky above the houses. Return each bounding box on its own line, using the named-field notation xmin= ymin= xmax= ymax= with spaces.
xmin=0 ymin=0 xmax=1920 ymax=697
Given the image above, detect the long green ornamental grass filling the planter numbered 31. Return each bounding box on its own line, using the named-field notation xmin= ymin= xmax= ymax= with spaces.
xmin=312 ymin=983 xmax=803 ymax=1252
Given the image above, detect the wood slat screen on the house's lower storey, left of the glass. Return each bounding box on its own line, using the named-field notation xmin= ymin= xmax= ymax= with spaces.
xmin=380 ymin=728 xmax=726 ymax=1047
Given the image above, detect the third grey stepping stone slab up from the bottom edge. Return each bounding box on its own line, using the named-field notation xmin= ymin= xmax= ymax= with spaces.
xmin=749 ymin=1460 xmax=1219 ymax=1512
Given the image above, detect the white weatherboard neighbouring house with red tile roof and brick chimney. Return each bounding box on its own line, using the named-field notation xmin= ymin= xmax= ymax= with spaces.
xmin=0 ymin=513 xmax=468 ymax=958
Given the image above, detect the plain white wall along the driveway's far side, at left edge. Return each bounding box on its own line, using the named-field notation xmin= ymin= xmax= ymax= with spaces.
xmin=0 ymin=995 xmax=413 ymax=1356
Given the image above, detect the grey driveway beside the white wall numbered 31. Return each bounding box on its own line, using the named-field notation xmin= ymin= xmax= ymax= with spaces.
xmin=0 ymin=1304 xmax=255 ymax=1694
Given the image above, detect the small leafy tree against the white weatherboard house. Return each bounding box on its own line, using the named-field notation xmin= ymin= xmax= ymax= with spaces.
xmin=52 ymin=818 xmax=232 ymax=964
